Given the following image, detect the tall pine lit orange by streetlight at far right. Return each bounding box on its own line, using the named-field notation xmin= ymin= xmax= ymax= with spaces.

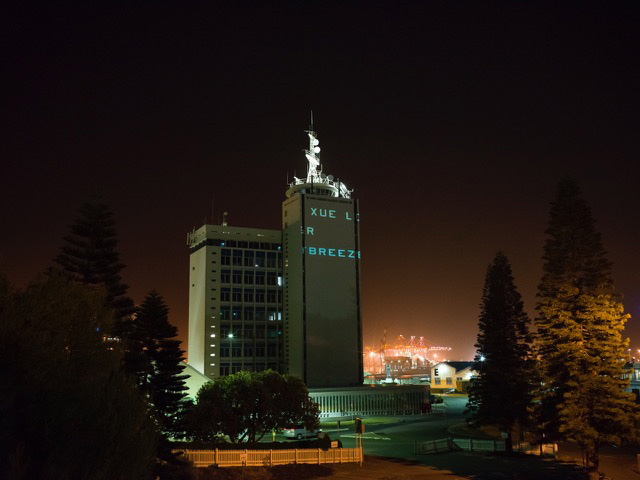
xmin=536 ymin=179 xmax=638 ymax=474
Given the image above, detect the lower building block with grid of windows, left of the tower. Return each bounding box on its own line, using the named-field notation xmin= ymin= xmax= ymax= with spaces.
xmin=187 ymin=225 xmax=284 ymax=379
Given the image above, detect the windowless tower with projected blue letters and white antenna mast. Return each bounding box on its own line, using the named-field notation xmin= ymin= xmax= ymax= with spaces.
xmin=282 ymin=128 xmax=363 ymax=388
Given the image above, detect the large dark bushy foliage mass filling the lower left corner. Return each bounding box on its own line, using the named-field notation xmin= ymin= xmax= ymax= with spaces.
xmin=0 ymin=271 xmax=156 ymax=480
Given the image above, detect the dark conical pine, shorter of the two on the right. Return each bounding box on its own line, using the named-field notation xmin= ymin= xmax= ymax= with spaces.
xmin=469 ymin=252 xmax=533 ymax=451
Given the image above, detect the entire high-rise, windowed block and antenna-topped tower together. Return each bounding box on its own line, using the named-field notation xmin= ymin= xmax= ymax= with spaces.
xmin=187 ymin=124 xmax=363 ymax=388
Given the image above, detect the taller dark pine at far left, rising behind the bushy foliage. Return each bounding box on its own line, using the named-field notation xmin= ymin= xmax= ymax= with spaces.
xmin=55 ymin=199 xmax=134 ymax=337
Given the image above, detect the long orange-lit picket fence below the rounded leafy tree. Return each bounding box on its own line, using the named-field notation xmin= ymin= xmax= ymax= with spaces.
xmin=182 ymin=448 xmax=362 ymax=467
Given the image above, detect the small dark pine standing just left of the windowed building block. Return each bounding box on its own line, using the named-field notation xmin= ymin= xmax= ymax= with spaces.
xmin=130 ymin=291 xmax=187 ymax=437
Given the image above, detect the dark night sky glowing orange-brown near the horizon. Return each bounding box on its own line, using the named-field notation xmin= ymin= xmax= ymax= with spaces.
xmin=0 ymin=2 xmax=640 ymax=358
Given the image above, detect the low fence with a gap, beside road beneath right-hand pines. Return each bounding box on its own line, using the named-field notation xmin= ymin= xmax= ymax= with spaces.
xmin=414 ymin=438 xmax=558 ymax=458
